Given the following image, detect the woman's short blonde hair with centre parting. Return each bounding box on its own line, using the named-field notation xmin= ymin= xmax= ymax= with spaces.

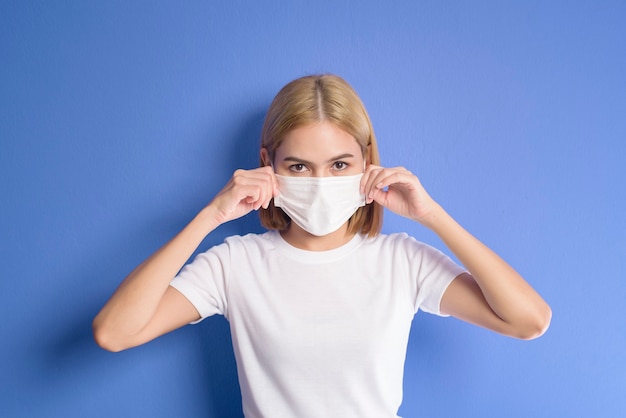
xmin=259 ymin=74 xmax=383 ymax=237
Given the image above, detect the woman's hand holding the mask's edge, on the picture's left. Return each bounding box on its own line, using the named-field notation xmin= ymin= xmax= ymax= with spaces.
xmin=208 ymin=166 xmax=278 ymax=224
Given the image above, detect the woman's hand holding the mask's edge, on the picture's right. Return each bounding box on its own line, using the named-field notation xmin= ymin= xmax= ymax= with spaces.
xmin=361 ymin=165 xmax=438 ymax=224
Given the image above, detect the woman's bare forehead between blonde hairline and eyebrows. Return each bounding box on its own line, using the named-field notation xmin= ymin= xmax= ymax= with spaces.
xmin=276 ymin=121 xmax=362 ymax=158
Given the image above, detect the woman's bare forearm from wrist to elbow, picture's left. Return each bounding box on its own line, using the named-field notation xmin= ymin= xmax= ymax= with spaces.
xmin=93 ymin=207 xmax=219 ymax=335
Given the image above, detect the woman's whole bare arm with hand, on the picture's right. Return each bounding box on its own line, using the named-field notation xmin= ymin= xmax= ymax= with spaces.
xmin=361 ymin=166 xmax=552 ymax=339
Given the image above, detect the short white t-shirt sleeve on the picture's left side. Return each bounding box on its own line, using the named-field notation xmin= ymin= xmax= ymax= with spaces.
xmin=170 ymin=240 xmax=230 ymax=323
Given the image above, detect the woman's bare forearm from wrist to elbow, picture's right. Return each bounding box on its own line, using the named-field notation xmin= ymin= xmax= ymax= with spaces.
xmin=426 ymin=205 xmax=551 ymax=329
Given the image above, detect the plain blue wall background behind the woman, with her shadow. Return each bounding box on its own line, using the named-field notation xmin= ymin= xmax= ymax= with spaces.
xmin=0 ymin=0 xmax=626 ymax=417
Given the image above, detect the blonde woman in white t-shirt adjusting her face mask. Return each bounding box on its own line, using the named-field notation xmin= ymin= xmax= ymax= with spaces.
xmin=94 ymin=75 xmax=551 ymax=418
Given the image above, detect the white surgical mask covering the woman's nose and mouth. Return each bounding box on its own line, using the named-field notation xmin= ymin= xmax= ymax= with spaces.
xmin=274 ymin=174 xmax=365 ymax=236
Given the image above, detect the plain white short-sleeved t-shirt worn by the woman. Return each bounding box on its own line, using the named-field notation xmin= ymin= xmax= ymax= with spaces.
xmin=172 ymin=231 xmax=464 ymax=418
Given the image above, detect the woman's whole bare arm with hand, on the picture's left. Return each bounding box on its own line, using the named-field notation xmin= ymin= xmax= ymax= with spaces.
xmin=93 ymin=168 xmax=278 ymax=351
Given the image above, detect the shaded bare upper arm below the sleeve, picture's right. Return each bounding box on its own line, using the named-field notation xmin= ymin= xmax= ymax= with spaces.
xmin=440 ymin=273 xmax=513 ymax=335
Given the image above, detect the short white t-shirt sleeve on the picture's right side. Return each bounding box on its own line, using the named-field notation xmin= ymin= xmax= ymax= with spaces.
xmin=408 ymin=237 xmax=466 ymax=316
